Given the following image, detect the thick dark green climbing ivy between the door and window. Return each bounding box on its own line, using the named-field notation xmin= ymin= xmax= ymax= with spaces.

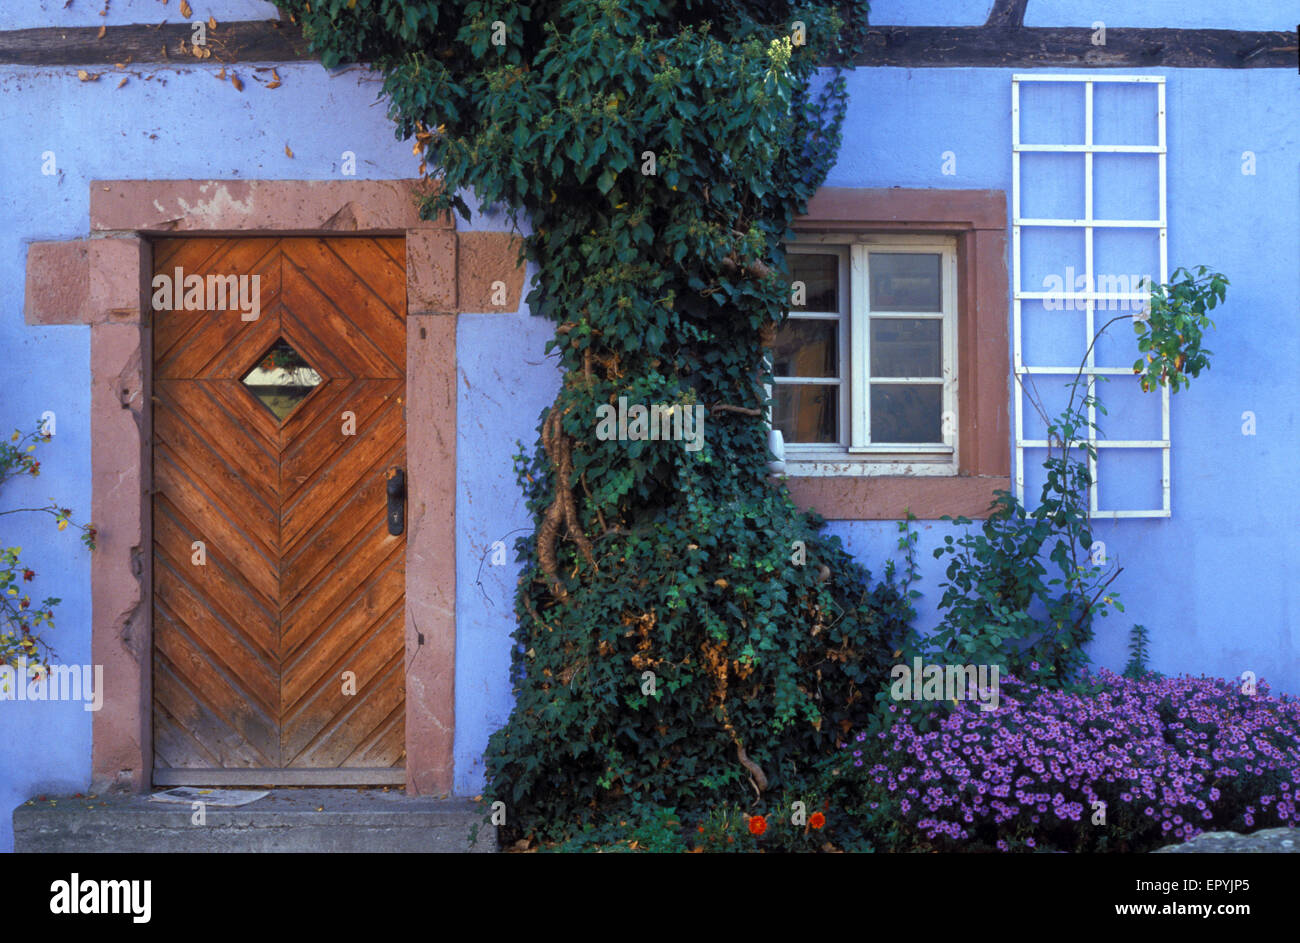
xmin=277 ymin=0 xmax=913 ymax=838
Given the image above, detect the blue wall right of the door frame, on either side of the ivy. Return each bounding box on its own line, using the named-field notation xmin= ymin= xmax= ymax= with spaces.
xmin=456 ymin=58 xmax=1300 ymax=791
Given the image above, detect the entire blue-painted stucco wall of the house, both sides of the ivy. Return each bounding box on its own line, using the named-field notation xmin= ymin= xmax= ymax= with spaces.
xmin=0 ymin=0 xmax=1300 ymax=849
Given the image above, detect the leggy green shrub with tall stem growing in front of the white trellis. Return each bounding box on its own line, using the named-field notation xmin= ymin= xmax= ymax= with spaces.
xmin=918 ymin=265 xmax=1229 ymax=684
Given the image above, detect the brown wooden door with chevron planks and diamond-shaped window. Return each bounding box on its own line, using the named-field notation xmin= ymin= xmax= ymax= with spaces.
xmin=152 ymin=238 xmax=406 ymax=784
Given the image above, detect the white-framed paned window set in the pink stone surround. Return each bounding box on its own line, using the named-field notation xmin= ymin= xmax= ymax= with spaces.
xmin=771 ymin=234 xmax=957 ymax=475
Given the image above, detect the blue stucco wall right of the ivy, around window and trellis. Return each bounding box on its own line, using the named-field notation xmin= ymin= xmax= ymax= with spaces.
xmin=827 ymin=60 xmax=1300 ymax=692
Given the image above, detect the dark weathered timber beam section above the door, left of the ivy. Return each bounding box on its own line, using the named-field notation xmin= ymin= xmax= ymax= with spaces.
xmin=0 ymin=20 xmax=316 ymax=65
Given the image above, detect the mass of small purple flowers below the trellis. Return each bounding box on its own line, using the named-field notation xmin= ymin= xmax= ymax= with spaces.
xmin=840 ymin=671 xmax=1300 ymax=851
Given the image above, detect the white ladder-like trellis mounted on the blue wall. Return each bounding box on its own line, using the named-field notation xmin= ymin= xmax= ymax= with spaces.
xmin=1011 ymin=73 xmax=1170 ymax=518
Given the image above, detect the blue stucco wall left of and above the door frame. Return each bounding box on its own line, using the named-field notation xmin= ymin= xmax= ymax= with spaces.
xmin=0 ymin=64 xmax=501 ymax=849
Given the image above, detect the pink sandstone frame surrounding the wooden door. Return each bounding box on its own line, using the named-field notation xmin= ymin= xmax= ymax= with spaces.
xmin=25 ymin=179 xmax=524 ymax=795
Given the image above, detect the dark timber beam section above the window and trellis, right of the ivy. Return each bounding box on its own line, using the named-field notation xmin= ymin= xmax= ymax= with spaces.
xmin=854 ymin=26 xmax=1297 ymax=69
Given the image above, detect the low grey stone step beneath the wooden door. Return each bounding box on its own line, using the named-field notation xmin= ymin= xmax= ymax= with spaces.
xmin=13 ymin=788 xmax=497 ymax=853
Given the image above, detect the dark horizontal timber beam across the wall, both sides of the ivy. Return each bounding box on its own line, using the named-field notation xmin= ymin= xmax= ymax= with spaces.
xmin=0 ymin=18 xmax=1297 ymax=69
